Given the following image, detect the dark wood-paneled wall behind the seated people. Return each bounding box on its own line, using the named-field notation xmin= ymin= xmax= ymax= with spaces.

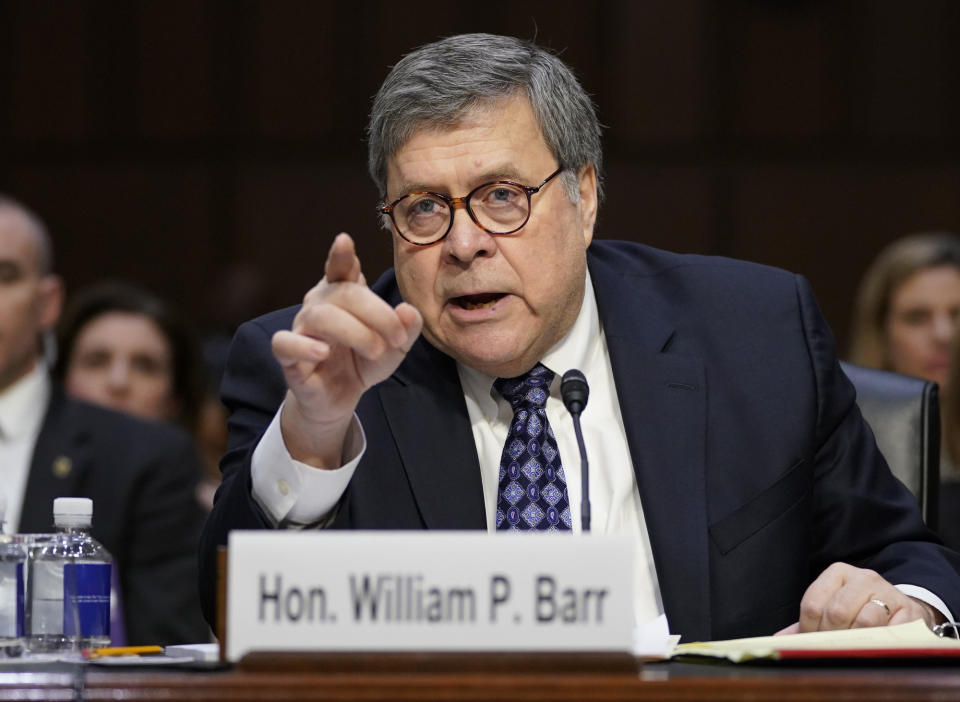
xmin=0 ymin=0 xmax=960 ymax=348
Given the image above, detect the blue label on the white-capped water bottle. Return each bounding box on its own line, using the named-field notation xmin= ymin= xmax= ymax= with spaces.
xmin=63 ymin=563 xmax=110 ymax=637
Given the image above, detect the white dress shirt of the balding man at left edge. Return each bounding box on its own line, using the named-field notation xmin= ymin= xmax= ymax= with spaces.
xmin=0 ymin=363 xmax=50 ymax=534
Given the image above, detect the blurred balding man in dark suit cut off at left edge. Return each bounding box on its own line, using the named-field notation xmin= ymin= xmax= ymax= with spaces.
xmin=0 ymin=198 xmax=209 ymax=644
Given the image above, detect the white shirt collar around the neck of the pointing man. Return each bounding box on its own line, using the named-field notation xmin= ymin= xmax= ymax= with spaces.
xmin=457 ymin=270 xmax=600 ymax=418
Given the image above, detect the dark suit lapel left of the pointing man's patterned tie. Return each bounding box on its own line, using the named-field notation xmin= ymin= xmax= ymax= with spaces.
xmin=378 ymin=337 xmax=486 ymax=529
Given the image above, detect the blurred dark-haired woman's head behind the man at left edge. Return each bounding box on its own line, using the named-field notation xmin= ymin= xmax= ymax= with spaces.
xmin=54 ymin=281 xmax=226 ymax=510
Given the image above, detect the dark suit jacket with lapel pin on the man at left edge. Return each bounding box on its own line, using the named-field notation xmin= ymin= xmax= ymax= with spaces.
xmin=20 ymin=386 xmax=210 ymax=644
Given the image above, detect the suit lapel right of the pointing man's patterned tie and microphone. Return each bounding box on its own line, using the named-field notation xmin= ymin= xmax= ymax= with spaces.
xmin=590 ymin=252 xmax=710 ymax=640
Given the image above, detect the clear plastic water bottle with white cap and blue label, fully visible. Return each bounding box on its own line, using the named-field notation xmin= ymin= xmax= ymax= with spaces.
xmin=26 ymin=497 xmax=113 ymax=653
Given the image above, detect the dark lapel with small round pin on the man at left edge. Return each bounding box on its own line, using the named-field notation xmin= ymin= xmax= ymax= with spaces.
xmin=19 ymin=385 xmax=89 ymax=533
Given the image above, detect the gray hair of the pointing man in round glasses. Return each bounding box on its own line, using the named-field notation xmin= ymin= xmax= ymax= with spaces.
xmin=367 ymin=34 xmax=603 ymax=202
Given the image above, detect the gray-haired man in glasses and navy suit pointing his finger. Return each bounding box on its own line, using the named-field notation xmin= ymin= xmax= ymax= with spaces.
xmin=201 ymin=35 xmax=960 ymax=639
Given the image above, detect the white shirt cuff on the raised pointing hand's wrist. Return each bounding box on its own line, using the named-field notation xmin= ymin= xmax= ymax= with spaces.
xmin=250 ymin=405 xmax=367 ymax=526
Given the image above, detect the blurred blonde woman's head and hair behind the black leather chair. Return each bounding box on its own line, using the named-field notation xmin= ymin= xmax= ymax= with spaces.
xmin=850 ymin=232 xmax=960 ymax=548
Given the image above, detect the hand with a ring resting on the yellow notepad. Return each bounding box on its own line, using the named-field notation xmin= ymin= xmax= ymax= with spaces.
xmin=777 ymin=563 xmax=943 ymax=634
